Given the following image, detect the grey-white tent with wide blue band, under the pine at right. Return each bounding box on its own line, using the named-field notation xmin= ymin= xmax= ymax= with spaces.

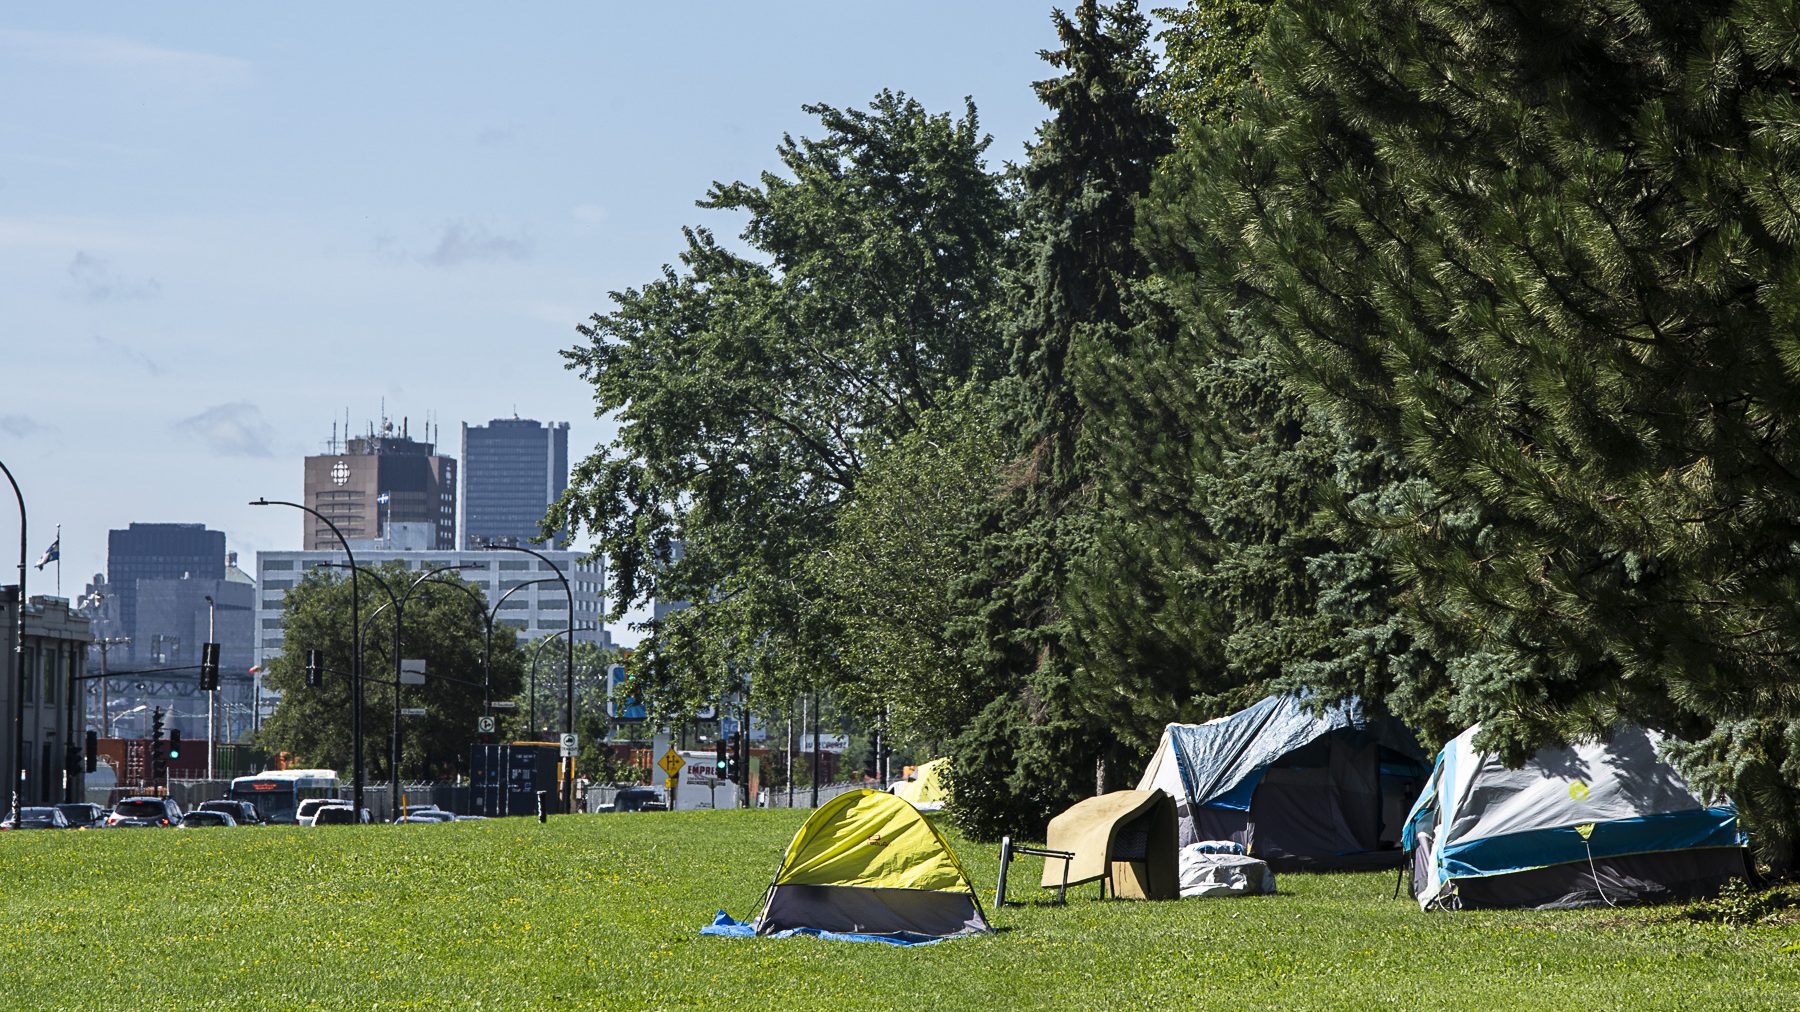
xmin=1404 ymin=724 xmax=1746 ymax=909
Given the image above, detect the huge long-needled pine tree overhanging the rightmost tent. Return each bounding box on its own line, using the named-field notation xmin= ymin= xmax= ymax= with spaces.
xmin=1188 ymin=0 xmax=1800 ymax=859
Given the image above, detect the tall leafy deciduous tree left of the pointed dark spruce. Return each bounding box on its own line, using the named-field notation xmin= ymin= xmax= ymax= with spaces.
xmin=545 ymin=92 xmax=1010 ymax=713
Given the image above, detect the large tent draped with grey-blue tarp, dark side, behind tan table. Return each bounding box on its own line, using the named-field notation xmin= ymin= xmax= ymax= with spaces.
xmin=1138 ymin=695 xmax=1429 ymax=872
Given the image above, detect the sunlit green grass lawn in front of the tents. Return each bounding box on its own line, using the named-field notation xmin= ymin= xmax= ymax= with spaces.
xmin=0 ymin=810 xmax=1800 ymax=1012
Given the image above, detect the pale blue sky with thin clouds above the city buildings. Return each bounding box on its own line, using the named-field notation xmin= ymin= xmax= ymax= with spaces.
xmin=0 ymin=0 xmax=1055 ymax=641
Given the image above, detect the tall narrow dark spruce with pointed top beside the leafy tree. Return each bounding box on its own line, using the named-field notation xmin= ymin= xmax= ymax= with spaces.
xmin=952 ymin=0 xmax=1170 ymax=836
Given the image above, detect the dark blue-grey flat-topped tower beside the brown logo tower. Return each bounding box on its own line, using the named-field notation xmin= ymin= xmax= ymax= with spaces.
xmin=463 ymin=418 xmax=569 ymax=549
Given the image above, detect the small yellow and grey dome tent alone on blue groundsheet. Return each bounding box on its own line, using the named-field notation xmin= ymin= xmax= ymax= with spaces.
xmin=756 ymin=791 xmax=992 ymax=938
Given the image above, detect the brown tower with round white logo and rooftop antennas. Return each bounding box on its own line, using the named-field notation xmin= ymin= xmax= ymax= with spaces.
xmin=301 ymin=421 xmax=457 ymax=551
